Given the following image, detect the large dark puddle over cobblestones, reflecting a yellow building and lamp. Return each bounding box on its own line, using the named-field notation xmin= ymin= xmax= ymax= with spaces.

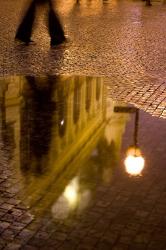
xmin=0 ymin=75 xmax=166 ymax=250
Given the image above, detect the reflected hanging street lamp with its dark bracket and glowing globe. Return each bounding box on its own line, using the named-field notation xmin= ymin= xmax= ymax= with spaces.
xmin=114 ymin=106 xmax=145 ymax=176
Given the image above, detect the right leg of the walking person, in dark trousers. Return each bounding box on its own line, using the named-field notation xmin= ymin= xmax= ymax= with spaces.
xmin=48 ymin=0 xmax=66 ymax=46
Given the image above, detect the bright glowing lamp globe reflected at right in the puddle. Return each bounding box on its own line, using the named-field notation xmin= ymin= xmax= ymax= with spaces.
xmin=124 ymin=155 xmax=145 ymax=176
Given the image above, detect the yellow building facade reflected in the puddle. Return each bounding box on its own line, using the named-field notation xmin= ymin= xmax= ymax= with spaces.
xmin=1 ymin=76 xmax=128 ymax=217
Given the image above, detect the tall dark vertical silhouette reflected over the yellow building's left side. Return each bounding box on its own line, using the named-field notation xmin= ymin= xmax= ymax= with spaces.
xmin=20 ymin=77 xmax=56 ymax=174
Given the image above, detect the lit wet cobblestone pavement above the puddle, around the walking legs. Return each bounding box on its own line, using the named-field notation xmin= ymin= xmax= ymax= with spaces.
xmin=0 ymin=0 xmax=166 ymax=118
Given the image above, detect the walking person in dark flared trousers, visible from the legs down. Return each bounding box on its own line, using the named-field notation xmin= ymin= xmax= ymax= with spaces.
xmin=15 ymin=0 xmax=66 ymax=47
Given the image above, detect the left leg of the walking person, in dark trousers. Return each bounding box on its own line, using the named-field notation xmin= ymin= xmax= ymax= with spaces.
xmin=15 ymin=0 xmax=36 ymax=44
